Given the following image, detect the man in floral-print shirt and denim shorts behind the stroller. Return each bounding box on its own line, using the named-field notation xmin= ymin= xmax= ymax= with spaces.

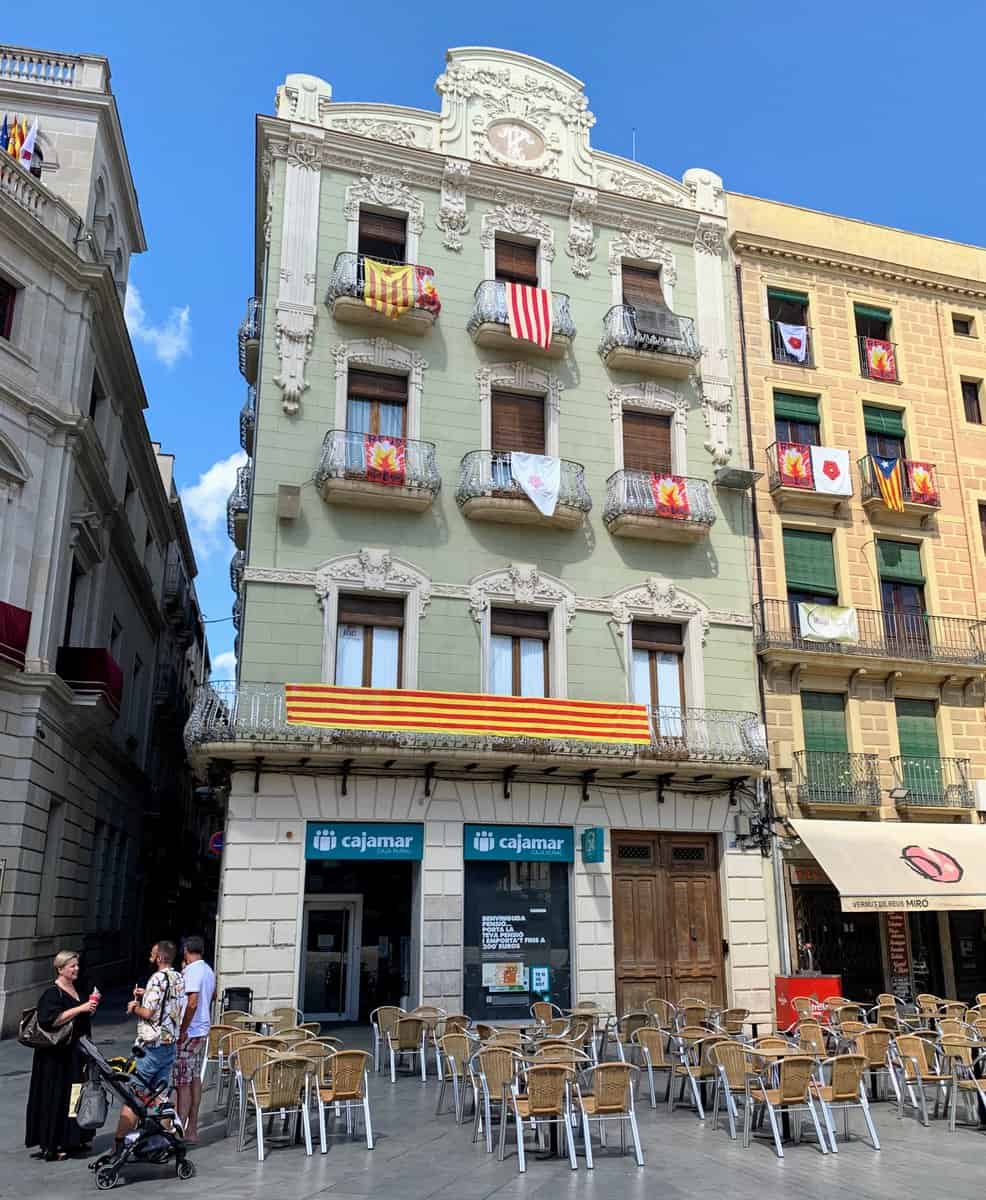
xmin=116 ymin=942 xmax=185 ymax=1150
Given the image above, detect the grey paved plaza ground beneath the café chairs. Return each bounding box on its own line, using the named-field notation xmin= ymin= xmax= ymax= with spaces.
xmin=0 ymin=1013 xmax=986 ymax=1200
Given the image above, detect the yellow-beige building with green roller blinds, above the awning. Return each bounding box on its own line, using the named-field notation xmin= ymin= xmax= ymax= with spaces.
xmin=728 ymin=194 xmax=986 ymax=1000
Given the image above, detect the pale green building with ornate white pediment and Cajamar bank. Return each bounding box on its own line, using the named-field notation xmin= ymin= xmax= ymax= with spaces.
xmin=187 ymin=48 xmax=770 ymax=1020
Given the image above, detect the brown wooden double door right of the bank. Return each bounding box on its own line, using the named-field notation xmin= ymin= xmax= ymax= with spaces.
xmin=612 ymin=830 xmax=726 ymax=1013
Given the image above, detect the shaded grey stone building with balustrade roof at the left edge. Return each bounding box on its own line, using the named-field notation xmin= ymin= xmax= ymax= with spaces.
xmin=0 ymin=46 xmax=208 ymax=1033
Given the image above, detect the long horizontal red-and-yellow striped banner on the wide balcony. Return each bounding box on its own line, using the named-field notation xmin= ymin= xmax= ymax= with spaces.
xmin=284 ymin=683 xmax=650 ymax=745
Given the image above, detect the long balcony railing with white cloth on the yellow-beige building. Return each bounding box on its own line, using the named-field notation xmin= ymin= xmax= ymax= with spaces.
xmin=753 ymin=600 xmax=986 ymax=666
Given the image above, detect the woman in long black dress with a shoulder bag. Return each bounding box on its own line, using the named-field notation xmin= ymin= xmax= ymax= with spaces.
xmin=24 ymin=950 xmax=98 ymax=1162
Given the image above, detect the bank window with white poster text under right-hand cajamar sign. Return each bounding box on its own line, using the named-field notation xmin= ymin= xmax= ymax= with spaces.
xmin=463 ymin=824 xmax=575 ymax=1020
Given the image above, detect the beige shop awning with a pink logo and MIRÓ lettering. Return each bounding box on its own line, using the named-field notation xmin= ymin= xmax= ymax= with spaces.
xmin=792 ymin=821 xmax=986 ymax=912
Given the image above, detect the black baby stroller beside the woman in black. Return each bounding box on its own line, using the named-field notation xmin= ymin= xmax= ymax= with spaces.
xmin=79 ymin=1038 xmax=196 ymax=1190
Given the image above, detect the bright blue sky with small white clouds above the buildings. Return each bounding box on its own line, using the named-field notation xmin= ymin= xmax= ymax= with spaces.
xmin=4 ymin=0 xmax=986 ymax=677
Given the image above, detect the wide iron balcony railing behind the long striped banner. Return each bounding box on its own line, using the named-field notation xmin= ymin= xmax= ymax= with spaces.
xmin=185 ymin=683 xmax=766 ymax=767
